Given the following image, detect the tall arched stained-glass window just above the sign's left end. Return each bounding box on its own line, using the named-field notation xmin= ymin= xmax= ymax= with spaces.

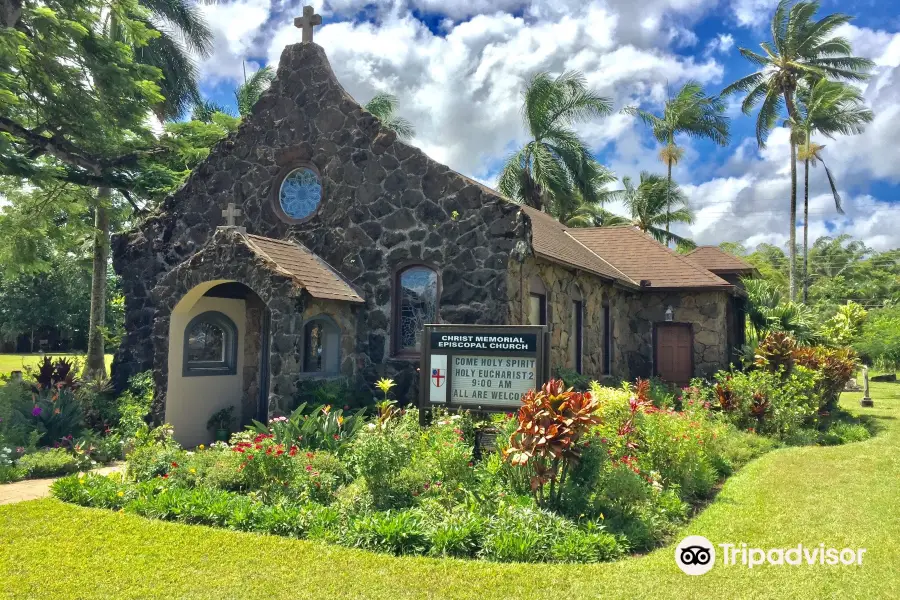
xmin=393 ymin=265 xmax=438 ymax=355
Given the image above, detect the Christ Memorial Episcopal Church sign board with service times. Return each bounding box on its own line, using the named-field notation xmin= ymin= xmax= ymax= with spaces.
xmin=419 ymin=325 xmax=549 ymax=416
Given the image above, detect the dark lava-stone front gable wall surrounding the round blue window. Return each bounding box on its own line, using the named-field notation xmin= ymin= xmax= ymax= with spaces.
xmin=113 ymin=44 xmax=528 ymax=399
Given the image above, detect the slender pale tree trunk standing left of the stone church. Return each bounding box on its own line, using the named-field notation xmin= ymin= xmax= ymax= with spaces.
xmin=84 ymin=188 xmax=112 ymax=378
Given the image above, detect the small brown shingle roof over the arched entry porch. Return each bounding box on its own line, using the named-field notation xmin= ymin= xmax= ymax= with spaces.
xmin=244 ymin=234 xmax=365 ymax=303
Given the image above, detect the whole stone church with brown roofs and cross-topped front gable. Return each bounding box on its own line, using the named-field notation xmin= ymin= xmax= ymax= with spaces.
xmin=113 ymin=18 xmax=752 ymax=446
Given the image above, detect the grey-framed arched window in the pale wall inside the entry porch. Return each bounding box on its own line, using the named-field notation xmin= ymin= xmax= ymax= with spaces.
xmin=183 ymin=311 xmax=237 ymax=377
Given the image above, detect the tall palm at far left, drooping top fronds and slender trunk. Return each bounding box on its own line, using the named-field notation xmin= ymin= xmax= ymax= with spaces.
xmin=84 ymin=0 xmax=212 ymax=377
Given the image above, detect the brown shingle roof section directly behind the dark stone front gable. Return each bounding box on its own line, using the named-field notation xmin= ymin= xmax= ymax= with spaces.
xmin=522 ymin=206 xmax=637 ymax=285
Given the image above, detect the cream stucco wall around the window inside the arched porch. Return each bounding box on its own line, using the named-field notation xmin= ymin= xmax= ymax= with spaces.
xmin=166 ymin=296 xmax=247 ymax=448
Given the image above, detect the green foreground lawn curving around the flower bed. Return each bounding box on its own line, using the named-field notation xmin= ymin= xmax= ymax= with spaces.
xmin=0 ymin=384 xmax=900 ymax=600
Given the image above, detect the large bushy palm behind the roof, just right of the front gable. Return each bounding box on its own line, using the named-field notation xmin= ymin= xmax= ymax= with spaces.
xmin=498 ymin=71 xmax=612 ymax=210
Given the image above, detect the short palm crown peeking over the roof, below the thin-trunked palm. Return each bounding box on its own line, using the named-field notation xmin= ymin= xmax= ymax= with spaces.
xmin=622 ymin=172 xmax=696 ymax=248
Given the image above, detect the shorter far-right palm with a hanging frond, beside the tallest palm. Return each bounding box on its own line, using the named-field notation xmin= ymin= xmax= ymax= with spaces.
xmin=791 ymin=79 xmax=874 ymax=303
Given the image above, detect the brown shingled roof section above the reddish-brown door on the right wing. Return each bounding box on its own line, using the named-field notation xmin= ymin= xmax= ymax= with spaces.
xmin=567 ymin=226 xmax=732 ymax=290
